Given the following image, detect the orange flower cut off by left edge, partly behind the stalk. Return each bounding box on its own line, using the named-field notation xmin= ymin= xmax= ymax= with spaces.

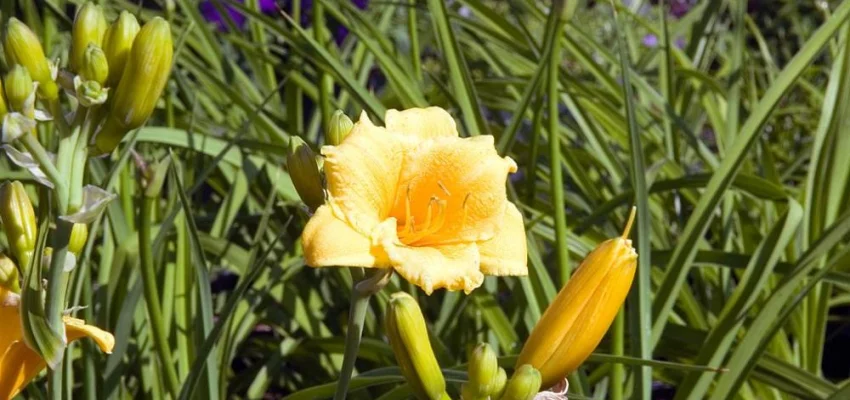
xmin=0 ymin=289 xmax=115 ymax=399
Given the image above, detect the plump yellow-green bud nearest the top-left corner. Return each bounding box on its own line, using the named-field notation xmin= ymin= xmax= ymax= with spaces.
xmin=3 ymin=17 xmax=59 ymax=100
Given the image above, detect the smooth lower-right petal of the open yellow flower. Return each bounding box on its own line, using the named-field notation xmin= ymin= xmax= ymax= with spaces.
xmin=478 ymin=202 xmax=528 ymax=275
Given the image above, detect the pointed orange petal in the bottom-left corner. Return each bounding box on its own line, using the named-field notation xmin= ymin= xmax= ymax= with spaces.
xmin=0 ymin=340 xmax=47 ymax=399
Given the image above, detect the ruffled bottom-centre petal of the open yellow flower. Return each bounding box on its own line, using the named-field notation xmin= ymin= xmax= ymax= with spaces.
xmin=380 ymin=224 xmax=484 ymax=295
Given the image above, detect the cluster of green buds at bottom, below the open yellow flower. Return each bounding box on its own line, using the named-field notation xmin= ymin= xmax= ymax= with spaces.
xmin=384 ymin=292 xmax=541 ymax=400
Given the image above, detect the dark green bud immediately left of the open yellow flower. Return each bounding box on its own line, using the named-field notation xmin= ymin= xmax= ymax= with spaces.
xmin=286 ymin=136 xmax=325 ymax=210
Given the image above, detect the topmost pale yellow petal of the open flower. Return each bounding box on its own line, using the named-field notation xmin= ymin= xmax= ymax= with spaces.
xmin=384 ymin=107 xmax=457 ymax=140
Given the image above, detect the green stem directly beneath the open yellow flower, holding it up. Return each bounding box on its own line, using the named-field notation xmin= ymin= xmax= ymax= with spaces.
xmin=334 ymin=268 xmax=393 ymax=400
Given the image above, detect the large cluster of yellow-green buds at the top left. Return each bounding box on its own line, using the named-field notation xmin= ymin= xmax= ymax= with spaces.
xmin=0 ymin=2 xmax=173 ymax=155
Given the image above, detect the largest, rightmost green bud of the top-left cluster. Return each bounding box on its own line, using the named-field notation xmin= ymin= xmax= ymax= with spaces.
xmin=95 ymin=17 xmax=174 ymax=154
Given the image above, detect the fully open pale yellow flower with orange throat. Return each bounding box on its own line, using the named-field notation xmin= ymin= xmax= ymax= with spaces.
xmin=302 ymin=107 xmax=528 ymax=294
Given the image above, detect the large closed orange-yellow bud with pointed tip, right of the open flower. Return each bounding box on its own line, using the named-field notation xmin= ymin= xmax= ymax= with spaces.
xmin=510 ymin=209 xmax=637 ymax=387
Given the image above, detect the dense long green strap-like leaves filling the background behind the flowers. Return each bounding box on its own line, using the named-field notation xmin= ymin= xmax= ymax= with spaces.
xmin=0 ymin=0 xmax=850 ymax=399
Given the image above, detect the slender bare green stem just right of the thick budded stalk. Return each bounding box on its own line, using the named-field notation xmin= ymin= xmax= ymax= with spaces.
xmin=139 ymin=196 xmax=180 ymax=399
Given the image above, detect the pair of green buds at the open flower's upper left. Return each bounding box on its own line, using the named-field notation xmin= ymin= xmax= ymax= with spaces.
xmin=286 ymin=110 xmax=354 ymax=211
